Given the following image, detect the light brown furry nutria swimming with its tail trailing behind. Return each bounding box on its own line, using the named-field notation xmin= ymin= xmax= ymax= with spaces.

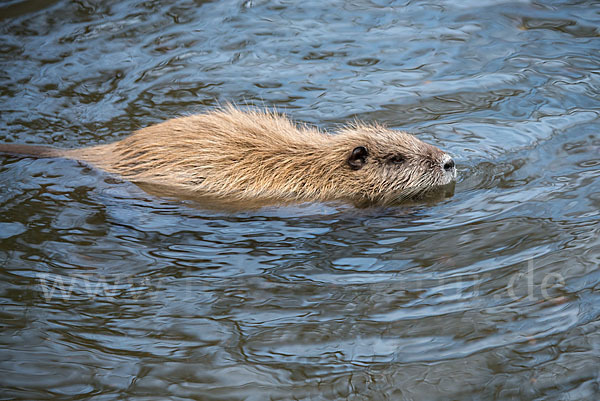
xmin=0 ymin=106 xmax=456 ymax=203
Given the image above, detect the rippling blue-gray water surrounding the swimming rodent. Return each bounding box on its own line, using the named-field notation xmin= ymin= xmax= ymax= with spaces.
xmin=0 ymin=0 xmax=600 ymax=401
